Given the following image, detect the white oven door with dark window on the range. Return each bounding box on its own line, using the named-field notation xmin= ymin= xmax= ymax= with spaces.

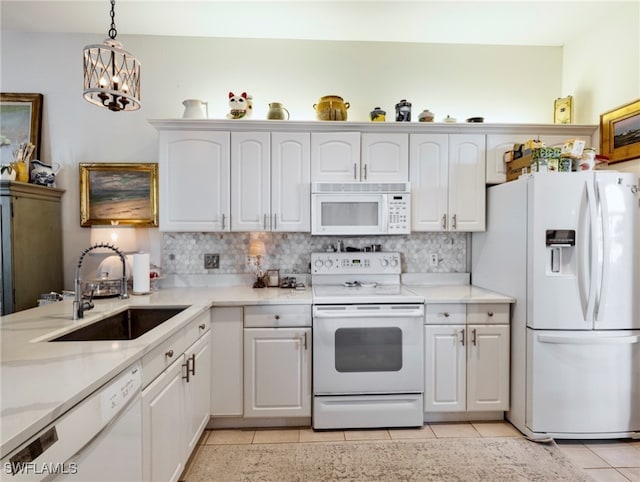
xmin=313 ymin=304 xmax=424 ymax=395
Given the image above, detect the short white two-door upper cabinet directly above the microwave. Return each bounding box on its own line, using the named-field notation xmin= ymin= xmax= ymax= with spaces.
xmin=311 ymin=132 xmax=409 ymax=182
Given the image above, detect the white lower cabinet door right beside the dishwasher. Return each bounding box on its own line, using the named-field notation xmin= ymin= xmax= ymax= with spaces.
xmin=142 ymin=355 xmax=185 ymax=482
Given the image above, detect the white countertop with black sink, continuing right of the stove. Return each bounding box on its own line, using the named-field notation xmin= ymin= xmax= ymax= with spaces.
xmin=0 ymin=285 xmax=513 ymax=457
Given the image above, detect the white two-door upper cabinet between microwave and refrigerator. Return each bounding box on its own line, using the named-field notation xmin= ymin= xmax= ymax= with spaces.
xmin=409 ymin=134 xmax=485 ymax=231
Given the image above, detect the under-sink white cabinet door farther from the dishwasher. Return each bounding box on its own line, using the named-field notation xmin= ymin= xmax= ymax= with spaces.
xmin=184 ymin=332 xmax=211 ymax=460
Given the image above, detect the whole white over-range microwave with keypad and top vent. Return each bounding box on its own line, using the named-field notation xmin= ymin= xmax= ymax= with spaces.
xmin=311 ymin=182 xmax=411 ymax=235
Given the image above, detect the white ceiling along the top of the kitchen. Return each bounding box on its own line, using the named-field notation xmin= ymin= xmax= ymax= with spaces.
xmin=0 ymin=0 xmax=638 ymax=46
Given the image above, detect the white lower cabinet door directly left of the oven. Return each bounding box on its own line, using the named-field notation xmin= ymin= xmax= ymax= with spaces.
xmin=244 ymin=328 xmax=311 ymax=417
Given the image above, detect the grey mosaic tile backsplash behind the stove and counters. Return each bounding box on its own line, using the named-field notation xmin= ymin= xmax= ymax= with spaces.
xmin=162 ymin=233 xmax=470 ymax=275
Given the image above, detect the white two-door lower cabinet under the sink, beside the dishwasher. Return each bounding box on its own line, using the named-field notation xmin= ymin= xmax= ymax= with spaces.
xmin=142 ymin=311 xmax=211 ymax=482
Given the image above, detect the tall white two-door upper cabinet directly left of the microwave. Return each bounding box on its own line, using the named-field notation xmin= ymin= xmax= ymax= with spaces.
xmin=231 ymin=132 xmax=311 ymax=232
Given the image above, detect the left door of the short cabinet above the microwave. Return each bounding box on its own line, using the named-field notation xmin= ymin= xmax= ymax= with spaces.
xmin=311 ymin=132 xmax=360 ymax=181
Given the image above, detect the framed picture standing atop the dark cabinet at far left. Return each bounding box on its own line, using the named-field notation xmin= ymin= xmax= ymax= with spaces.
xmin=0 ymin=92 xmax=43 ymax=164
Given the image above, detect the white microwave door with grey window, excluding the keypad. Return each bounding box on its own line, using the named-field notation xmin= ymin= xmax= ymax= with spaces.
xmin=311 ymin=193 xmax=388 ymax=235
